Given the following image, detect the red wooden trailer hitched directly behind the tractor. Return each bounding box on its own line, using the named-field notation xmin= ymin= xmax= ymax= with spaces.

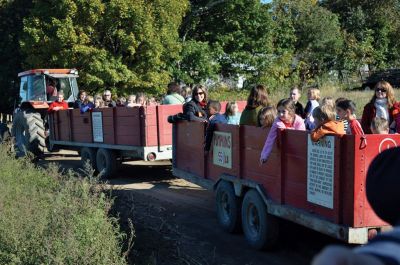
xmin=49 ymin=105 xmax=182 ymax=177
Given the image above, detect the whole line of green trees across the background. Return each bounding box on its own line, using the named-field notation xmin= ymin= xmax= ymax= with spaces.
xmin=0 ymin=0 xmax=400 ymax=109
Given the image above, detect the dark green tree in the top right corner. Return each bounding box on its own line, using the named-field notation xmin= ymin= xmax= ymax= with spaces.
xmin=322 ymin=0 xmax=400 ymax=70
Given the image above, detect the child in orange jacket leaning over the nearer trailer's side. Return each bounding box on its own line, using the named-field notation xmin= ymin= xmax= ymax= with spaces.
xmin=310 ymin=104 xmax=346 ymax=142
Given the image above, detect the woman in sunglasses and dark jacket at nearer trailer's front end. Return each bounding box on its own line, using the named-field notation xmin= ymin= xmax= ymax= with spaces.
xmin=183 ymin=85 xmax=207 ymax=122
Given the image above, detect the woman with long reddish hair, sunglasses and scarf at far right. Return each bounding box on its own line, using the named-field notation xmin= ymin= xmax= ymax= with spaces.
xmin=361 ymin=81 xmax=396 ymax=133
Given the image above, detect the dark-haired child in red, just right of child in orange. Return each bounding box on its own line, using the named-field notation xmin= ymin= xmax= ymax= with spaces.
xmin=336 ymin=100 xmax=364 ymax=135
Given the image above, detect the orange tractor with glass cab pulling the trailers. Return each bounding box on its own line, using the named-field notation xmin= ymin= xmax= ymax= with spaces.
xmin=12 ymin=69 xmax=78 ymax=156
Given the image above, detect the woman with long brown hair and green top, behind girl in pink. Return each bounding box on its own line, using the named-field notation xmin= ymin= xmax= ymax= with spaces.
xmin=239 ymin=85 xmax=269 ymax=126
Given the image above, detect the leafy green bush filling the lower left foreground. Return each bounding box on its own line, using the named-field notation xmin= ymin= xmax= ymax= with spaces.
xmin=0 ymin=146 xmax=126 ymax=264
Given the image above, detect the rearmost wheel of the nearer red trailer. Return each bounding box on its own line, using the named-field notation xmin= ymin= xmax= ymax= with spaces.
xmin=242 ymin=190 xmax=279 ymax=249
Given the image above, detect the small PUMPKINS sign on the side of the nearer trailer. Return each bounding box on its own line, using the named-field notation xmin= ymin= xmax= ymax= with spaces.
xmin=213 ymin=132 xmax=232 ymax=168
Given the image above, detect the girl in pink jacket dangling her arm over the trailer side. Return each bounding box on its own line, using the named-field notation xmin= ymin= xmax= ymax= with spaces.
xmin=260 ymin=99 xmax=306 ymax=164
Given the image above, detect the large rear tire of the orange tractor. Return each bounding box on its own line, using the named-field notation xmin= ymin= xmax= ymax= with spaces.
xmin=12 ymin=111 xmax=46 ymax=157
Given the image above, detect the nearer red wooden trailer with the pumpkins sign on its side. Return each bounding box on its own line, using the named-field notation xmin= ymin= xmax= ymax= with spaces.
xmin=173 ymin=122 xmax=394 ymax=249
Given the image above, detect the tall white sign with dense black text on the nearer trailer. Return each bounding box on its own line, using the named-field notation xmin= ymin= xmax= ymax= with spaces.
xmin=307 ymin=136 xmax=335 ymax=209
